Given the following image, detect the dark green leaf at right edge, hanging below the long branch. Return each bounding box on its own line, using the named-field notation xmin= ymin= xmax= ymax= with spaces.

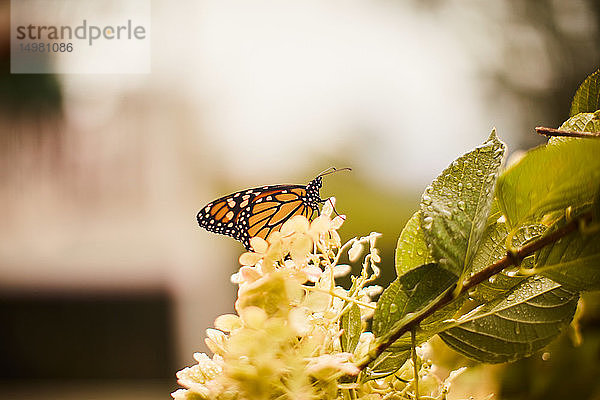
xmin=535 ymin=212 xmax=600 ymax=291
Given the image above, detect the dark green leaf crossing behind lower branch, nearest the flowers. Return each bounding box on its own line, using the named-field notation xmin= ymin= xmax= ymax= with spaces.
xmin=369 ymin=264 xmax=462 ymax=379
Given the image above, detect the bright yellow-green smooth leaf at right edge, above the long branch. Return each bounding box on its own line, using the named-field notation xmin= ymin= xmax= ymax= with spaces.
xmin=496 ymin=139 xmax=600 ymax=228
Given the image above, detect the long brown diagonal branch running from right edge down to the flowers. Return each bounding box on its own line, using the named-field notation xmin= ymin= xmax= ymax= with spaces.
xmin=357 ymin=212 xmax=593 ymax=370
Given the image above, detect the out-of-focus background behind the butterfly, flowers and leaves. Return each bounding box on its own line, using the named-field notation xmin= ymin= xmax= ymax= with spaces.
xmin=0 ymin=0 xmax=600 ymax=399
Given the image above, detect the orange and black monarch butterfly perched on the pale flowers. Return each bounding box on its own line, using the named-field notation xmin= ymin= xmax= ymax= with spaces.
xmin=196 ymin=167 xmax=351 ymax=250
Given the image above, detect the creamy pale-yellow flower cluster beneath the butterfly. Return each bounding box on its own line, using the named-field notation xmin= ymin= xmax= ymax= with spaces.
xmin=172 ymin=198 xmax=464 ymax=400
